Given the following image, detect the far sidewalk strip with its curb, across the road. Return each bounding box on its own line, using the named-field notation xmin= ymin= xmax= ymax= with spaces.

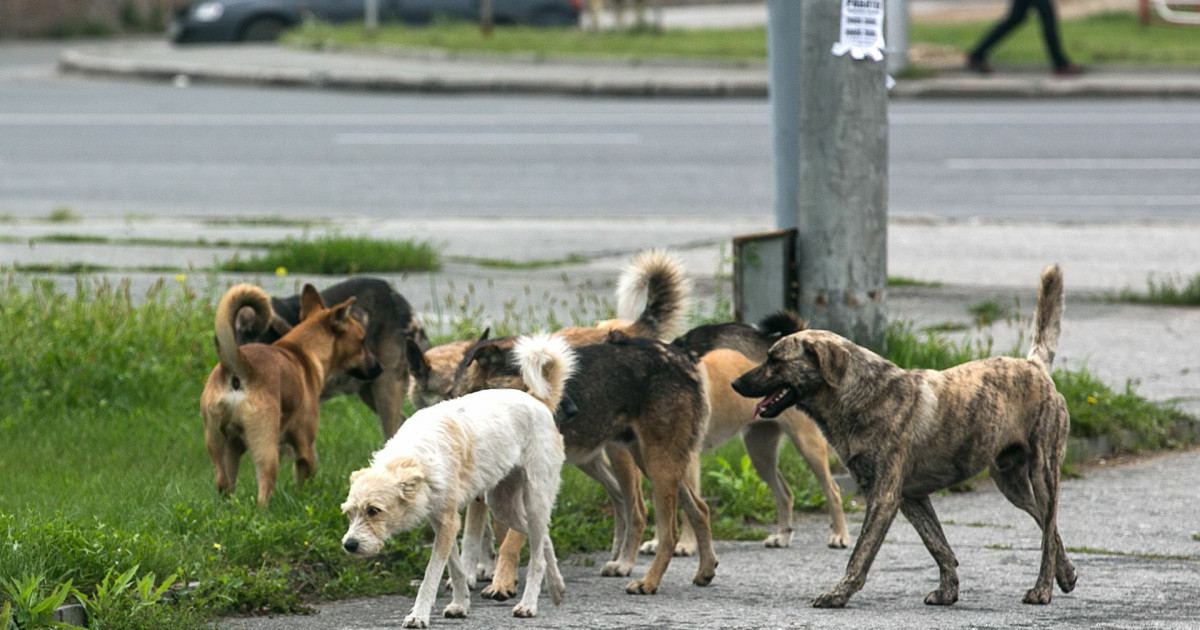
xmin=59 ymin=41 xmax=1200 ymax=98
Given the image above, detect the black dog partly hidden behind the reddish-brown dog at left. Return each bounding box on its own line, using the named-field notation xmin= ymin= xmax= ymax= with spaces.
xmin=234 ymin=277 xmax=427 ymax=439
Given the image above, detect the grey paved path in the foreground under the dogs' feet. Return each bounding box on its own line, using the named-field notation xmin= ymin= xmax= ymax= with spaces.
xmin=222 ymin=451 xmax=1200 ymax=630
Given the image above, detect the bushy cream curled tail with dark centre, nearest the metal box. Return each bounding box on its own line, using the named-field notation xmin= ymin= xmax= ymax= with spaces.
xmin=617 ymin=250 xmax=691 ymax=338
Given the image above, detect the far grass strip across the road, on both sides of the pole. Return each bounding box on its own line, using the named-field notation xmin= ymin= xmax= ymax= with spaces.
xmin=283 ymin=12 xmax=1200 ymax=67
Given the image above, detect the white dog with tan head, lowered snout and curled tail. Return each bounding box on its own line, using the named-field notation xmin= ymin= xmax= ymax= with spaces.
xmin=342 ymin=335 xmax=575 ymax=628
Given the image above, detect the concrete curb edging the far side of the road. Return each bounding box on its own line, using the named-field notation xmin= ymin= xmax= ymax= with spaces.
xmin=59 ymin=49 xmax=1200 ymax=98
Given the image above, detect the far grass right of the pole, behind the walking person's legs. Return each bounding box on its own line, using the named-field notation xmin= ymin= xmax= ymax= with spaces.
xmin=908 ymin=12 xmax=1200 ymax=67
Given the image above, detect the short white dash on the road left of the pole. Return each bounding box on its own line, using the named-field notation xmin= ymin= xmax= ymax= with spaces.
xmin=334 ymin=133 xmax=642 ymax=146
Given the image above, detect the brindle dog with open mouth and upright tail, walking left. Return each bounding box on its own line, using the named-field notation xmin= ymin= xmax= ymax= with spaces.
xmin=733 ymin=265 xmax=1075 ymax=607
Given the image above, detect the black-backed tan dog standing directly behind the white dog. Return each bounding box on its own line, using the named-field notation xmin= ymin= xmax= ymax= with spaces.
xmin=455 ymin=331 xmax=716 ymax=595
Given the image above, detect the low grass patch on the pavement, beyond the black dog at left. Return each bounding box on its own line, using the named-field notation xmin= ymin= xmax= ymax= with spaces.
xmin=218 ymin=236 xmax=440 ymax=275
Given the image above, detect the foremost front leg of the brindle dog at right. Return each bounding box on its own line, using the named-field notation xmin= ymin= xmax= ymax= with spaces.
xmin=812 ymin=456 xmax=902 ymax=608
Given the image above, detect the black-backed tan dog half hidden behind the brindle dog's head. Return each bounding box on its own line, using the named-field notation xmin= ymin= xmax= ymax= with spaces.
xmin=642 ymin=313 xmax=850 ymax=556
